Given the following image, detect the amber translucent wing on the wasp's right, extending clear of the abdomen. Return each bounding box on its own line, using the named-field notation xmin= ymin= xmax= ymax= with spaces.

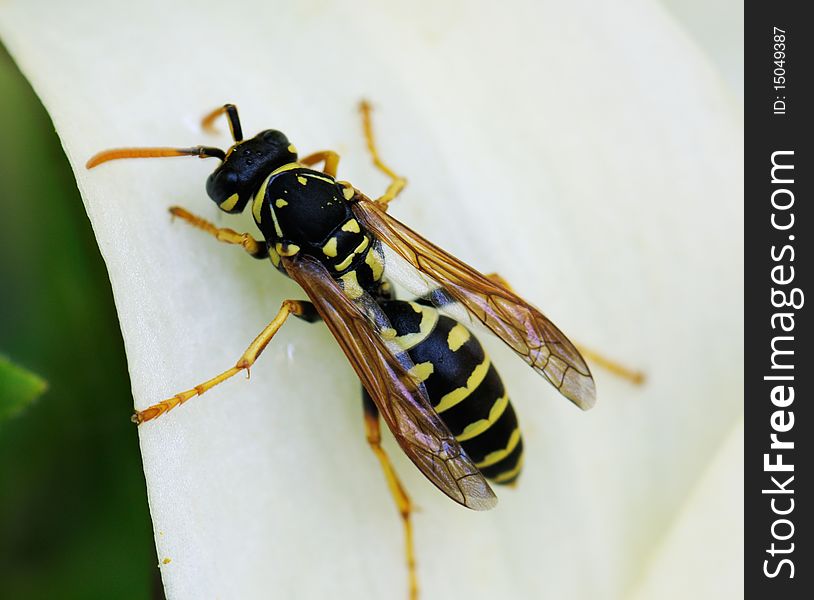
xmin=351 ymin=194 xmax=596 ymax=410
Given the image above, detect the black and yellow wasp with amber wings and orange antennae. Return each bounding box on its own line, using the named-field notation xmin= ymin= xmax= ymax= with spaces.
xmin=87 ymin=102 xmax=636 ymax=598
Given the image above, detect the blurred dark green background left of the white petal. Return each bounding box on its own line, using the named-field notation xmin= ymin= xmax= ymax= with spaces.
xmin=0 ymin=47 xmax=160 ymax=600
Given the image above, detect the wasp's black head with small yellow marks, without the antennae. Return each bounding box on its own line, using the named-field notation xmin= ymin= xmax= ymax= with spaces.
xmin=206 ymin=129 xmax=297 ymax=213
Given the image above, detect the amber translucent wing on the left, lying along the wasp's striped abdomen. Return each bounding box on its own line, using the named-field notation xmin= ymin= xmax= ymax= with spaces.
xmin=283 ymin=255 xmax=497 ymax=510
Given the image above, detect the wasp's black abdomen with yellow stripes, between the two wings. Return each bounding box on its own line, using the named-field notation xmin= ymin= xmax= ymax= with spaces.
xmin=380 ymin=300 xmax=523 ymax=483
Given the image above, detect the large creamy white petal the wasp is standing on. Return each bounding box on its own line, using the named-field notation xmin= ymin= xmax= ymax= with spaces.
xmin=0 ymin=0 xmax=743 ymax=599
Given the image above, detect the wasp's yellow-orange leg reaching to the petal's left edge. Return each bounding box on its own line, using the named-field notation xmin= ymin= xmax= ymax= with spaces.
xmin=132 ymin=300 xmax=316 ymax=425
